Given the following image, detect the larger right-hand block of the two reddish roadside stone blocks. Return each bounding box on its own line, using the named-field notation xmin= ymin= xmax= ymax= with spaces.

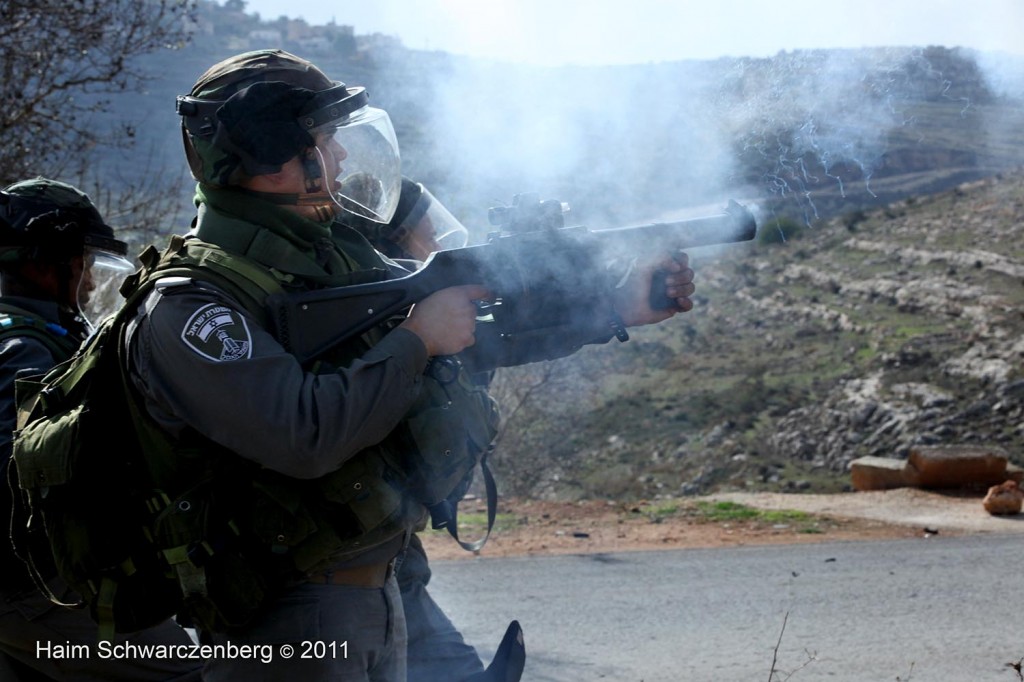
xmin=907 ymin=445 xmax=1020 ymax=489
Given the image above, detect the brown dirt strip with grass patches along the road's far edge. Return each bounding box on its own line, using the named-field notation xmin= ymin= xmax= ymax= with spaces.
xmin=415 ymin=488 xmax=1024 ymax=559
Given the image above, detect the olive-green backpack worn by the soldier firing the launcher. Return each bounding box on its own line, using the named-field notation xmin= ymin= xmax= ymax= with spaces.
xmin=12 ymin=274 xmax=180 ymax=640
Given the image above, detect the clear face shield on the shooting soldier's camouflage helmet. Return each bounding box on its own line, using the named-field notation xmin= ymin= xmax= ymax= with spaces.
xmin=311 ymin=106 xmax=401 ymax=223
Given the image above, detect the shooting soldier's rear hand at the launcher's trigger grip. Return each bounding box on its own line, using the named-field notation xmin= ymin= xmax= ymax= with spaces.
xmin=399 ymin=285 xmax=490 ymax=356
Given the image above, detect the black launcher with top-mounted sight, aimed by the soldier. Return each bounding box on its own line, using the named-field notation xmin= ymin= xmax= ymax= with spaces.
xmin=267 ymin=194 xmax=757 ymax=369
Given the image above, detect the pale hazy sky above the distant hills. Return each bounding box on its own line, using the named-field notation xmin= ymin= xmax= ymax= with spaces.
xmin=237 ymin=0 xmax=1024 ymax=65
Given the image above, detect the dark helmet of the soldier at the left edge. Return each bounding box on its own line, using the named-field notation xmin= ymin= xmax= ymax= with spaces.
xmin=0 ymin=177 xmax=128 ymax=263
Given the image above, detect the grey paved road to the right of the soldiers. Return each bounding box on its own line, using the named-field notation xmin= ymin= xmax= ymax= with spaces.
xmin=431 ymin=535 xmax=1024 ymax=682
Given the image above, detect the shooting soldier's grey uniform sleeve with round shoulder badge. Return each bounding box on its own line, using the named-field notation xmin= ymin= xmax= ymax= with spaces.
xmin=128 ymin=288 xmax=427 ymax=478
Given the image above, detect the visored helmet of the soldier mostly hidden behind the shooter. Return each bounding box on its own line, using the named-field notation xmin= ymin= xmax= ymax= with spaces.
xmin=358 ymin=177 xmax=469 ymax=260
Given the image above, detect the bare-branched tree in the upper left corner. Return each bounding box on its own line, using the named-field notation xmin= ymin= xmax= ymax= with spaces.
xmin=0 ymin=0 xmax=195 ymax=184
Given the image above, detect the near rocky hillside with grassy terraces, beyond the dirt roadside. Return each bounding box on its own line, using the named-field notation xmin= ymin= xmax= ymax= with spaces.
xmin=495 ymin=172 xmax=1024 ymax=498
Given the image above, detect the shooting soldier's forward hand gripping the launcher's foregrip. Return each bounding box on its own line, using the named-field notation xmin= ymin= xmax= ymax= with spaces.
xmin=614 ymin=252 xmax=695 ymax=327
